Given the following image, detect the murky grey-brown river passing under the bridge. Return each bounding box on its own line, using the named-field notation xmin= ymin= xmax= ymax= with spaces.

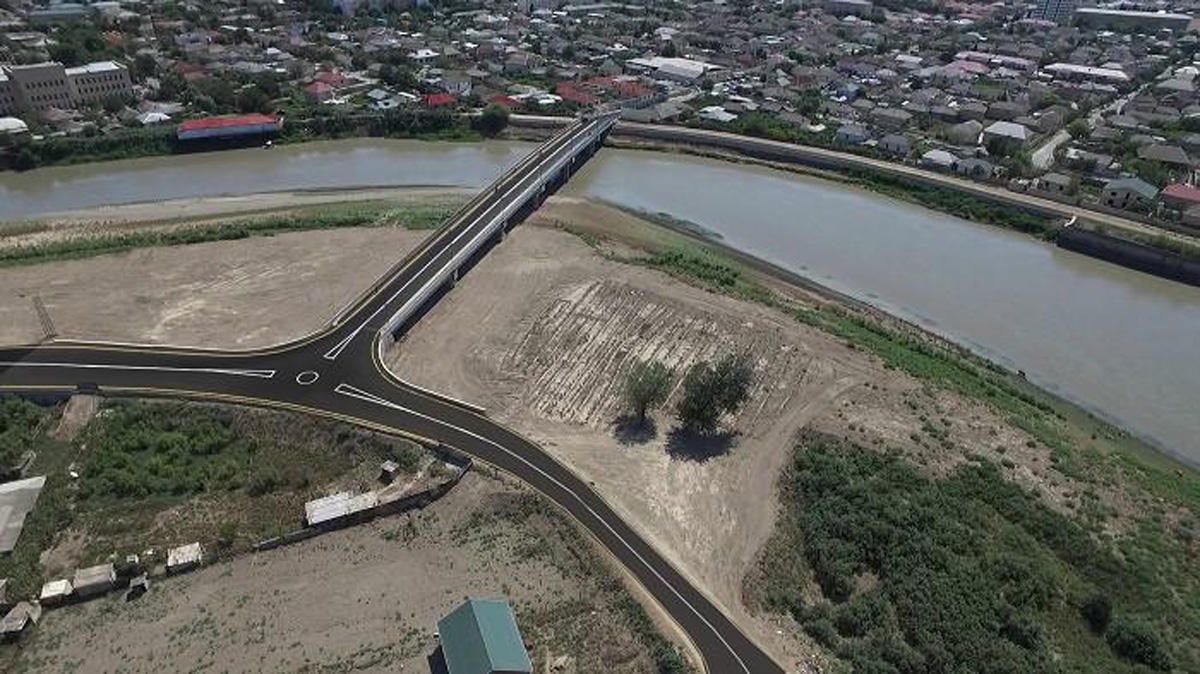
xmin=0 ymin=139 xmax=1200 ymax=465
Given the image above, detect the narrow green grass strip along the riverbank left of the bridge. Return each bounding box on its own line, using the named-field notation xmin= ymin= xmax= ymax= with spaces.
xmin=0 ymin=197 xmax=456 ymax=266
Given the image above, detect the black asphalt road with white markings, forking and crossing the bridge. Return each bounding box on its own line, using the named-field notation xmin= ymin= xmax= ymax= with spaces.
xmin=0 ymin=111 xmax=782 ymax=674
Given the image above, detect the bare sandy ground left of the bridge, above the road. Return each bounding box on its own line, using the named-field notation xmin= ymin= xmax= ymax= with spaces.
xmin=0 ymin=228 xmax=428 ymax=349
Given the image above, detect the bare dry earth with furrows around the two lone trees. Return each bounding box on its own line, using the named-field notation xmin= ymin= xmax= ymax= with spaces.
xmin=389 ymin=199 xmax=1104 ymax=670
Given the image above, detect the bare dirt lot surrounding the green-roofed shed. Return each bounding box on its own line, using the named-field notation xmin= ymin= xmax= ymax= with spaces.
xmin=10 ymin=474 xmax=654 ymax=674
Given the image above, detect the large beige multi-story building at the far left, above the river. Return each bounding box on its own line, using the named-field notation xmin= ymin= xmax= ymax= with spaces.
xmin=0 ymin=61 xmax=133 ymax=115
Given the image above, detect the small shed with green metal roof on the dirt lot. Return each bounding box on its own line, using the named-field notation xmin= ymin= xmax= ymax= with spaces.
xmin=438 ymin=600 xmax=533 ymax=674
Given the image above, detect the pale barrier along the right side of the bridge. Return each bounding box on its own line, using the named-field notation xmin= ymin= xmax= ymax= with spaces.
xmin=379 ymin=115 xmax=617 ymax=345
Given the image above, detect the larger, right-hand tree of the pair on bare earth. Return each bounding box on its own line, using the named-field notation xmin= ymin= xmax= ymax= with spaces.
xmin=676 ymin=354 xmax=754 ymax=433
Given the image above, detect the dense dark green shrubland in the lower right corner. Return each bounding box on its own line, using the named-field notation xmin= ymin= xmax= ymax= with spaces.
xmin=756 ymin=433 xmax=1200 ymax=672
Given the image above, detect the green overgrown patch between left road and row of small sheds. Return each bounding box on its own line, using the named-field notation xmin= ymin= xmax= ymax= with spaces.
xmin=43 ymin=401 xmax=425 ymax=565
